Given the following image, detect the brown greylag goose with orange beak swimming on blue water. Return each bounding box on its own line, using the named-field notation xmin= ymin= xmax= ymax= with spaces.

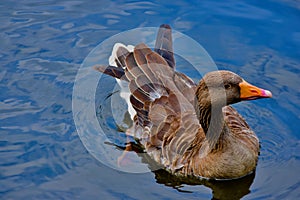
xmin=95 ymin=25 xmax=272 ymax=179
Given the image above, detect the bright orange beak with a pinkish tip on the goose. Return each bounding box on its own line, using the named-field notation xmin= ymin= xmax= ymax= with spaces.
xmin=239 ymin=80 xmax=272 ymax=101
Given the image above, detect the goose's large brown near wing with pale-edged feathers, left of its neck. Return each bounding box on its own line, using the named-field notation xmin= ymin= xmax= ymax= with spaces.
xmin=125 ymin=44 xmax=200 ymax=170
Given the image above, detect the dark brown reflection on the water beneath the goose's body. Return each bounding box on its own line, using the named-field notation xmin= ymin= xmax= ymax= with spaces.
xmin=102 ymin=127 xmax=255 ymax=200
